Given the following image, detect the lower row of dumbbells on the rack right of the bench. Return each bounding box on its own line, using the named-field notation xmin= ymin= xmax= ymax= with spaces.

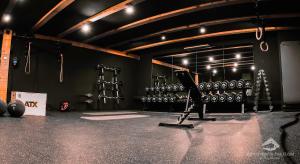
xmin=202 ymin=92 xmax=243 ymax=104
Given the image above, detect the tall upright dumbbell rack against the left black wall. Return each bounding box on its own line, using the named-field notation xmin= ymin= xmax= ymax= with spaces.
xmin=97 ymin=64 xmax=124 ymax=104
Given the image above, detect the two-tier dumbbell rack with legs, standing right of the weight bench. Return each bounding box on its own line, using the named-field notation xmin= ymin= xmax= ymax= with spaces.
xmin=199 ymin=80 xmax=250 ymax=114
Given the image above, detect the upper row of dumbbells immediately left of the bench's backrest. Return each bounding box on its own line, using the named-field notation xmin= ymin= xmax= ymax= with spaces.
xmin=145 ymin=84 xmax=184 ymax=93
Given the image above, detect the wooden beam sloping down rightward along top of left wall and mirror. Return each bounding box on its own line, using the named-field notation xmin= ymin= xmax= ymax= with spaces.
xmin=34 ymin=34 xmax=188 ymax=70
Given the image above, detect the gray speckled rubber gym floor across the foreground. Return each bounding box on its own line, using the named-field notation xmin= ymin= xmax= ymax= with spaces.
xmin=0 ymin=112 xmax=300 ymax=164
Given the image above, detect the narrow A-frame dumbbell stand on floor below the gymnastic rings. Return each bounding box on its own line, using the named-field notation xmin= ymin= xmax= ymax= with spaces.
xmin=253 ymin=69 xmax=273 ymax=112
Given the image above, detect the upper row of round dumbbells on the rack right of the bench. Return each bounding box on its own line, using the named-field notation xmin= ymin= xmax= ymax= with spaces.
xmin=198 ymin=79 xmax=252 ymax=91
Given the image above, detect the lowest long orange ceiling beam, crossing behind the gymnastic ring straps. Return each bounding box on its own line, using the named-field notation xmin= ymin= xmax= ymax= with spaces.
xmin=125 ymin=27 xmax=296 ymax=52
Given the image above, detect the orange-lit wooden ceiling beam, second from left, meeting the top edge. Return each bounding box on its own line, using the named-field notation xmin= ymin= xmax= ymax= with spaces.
xmin=58 ymin=0 xmax=136 ymax=37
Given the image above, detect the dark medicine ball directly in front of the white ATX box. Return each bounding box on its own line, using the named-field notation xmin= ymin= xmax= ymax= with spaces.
xmin=7 ymin=100 xmax=25 ymax=117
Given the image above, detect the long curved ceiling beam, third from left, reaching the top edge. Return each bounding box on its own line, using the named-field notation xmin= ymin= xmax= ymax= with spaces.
xmin=85 ymin=0 xmax=254 ymax=42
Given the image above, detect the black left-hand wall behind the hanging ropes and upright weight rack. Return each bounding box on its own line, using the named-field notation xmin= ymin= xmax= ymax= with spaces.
xmin=9 ymin=38 xmax=139 ymax=110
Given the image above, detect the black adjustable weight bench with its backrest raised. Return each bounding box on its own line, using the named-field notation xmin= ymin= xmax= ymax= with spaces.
xmin=159 ymin=71 xmax=216 ymax=128
